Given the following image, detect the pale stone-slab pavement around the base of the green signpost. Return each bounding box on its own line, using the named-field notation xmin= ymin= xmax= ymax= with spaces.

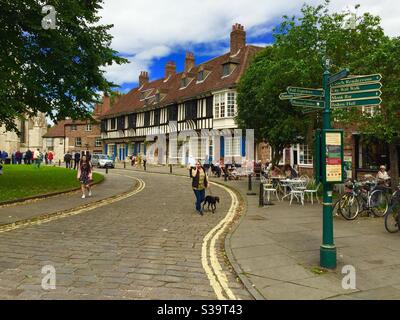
xmin=114 ymin=166 xmax=400 ymax=299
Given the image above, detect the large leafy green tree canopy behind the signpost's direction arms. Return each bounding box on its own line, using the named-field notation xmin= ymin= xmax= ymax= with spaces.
xmin=237 ymin=1 xmax=400 ymax=182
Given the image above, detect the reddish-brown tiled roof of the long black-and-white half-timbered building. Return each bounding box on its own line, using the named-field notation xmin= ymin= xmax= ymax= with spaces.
xmin=101 ymin=45 xmax=262 ymax=118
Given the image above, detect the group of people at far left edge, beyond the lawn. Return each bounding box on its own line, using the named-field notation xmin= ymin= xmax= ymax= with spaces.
xmin=0 ymin=149 xmax=54 ymax=168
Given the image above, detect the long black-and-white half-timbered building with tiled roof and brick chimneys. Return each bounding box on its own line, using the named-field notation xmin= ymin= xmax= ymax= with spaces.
xmin=101 ymin=24 xmax=262 ymax=163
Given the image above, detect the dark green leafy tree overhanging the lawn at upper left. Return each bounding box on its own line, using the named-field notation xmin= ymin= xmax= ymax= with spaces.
xmin=0 ymin=0 xmax=127 ymax=130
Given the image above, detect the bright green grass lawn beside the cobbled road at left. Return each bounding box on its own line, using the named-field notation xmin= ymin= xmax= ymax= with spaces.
xmin=0 ymin=165 xmax=104 ymax=202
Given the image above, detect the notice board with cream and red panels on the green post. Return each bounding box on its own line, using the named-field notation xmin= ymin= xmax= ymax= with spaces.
xmin=322 ymin=129 xmax=344 ymax=183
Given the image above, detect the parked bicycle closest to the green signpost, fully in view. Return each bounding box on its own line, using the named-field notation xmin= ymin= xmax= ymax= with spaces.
xmin=338 ymin=180 xmax=389 ymax=220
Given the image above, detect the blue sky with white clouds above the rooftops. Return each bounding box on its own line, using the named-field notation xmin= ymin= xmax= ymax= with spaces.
xmin=100 ymin=0 xmax=400 ymax=93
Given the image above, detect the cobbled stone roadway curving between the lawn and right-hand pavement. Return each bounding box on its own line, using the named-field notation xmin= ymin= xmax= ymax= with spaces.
xmin=0 ymin=170 xmax=251 ymax=299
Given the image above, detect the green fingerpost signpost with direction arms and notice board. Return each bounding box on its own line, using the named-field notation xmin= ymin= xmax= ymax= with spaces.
xmin=279 ymin=59 xmax=382 ymax=269
